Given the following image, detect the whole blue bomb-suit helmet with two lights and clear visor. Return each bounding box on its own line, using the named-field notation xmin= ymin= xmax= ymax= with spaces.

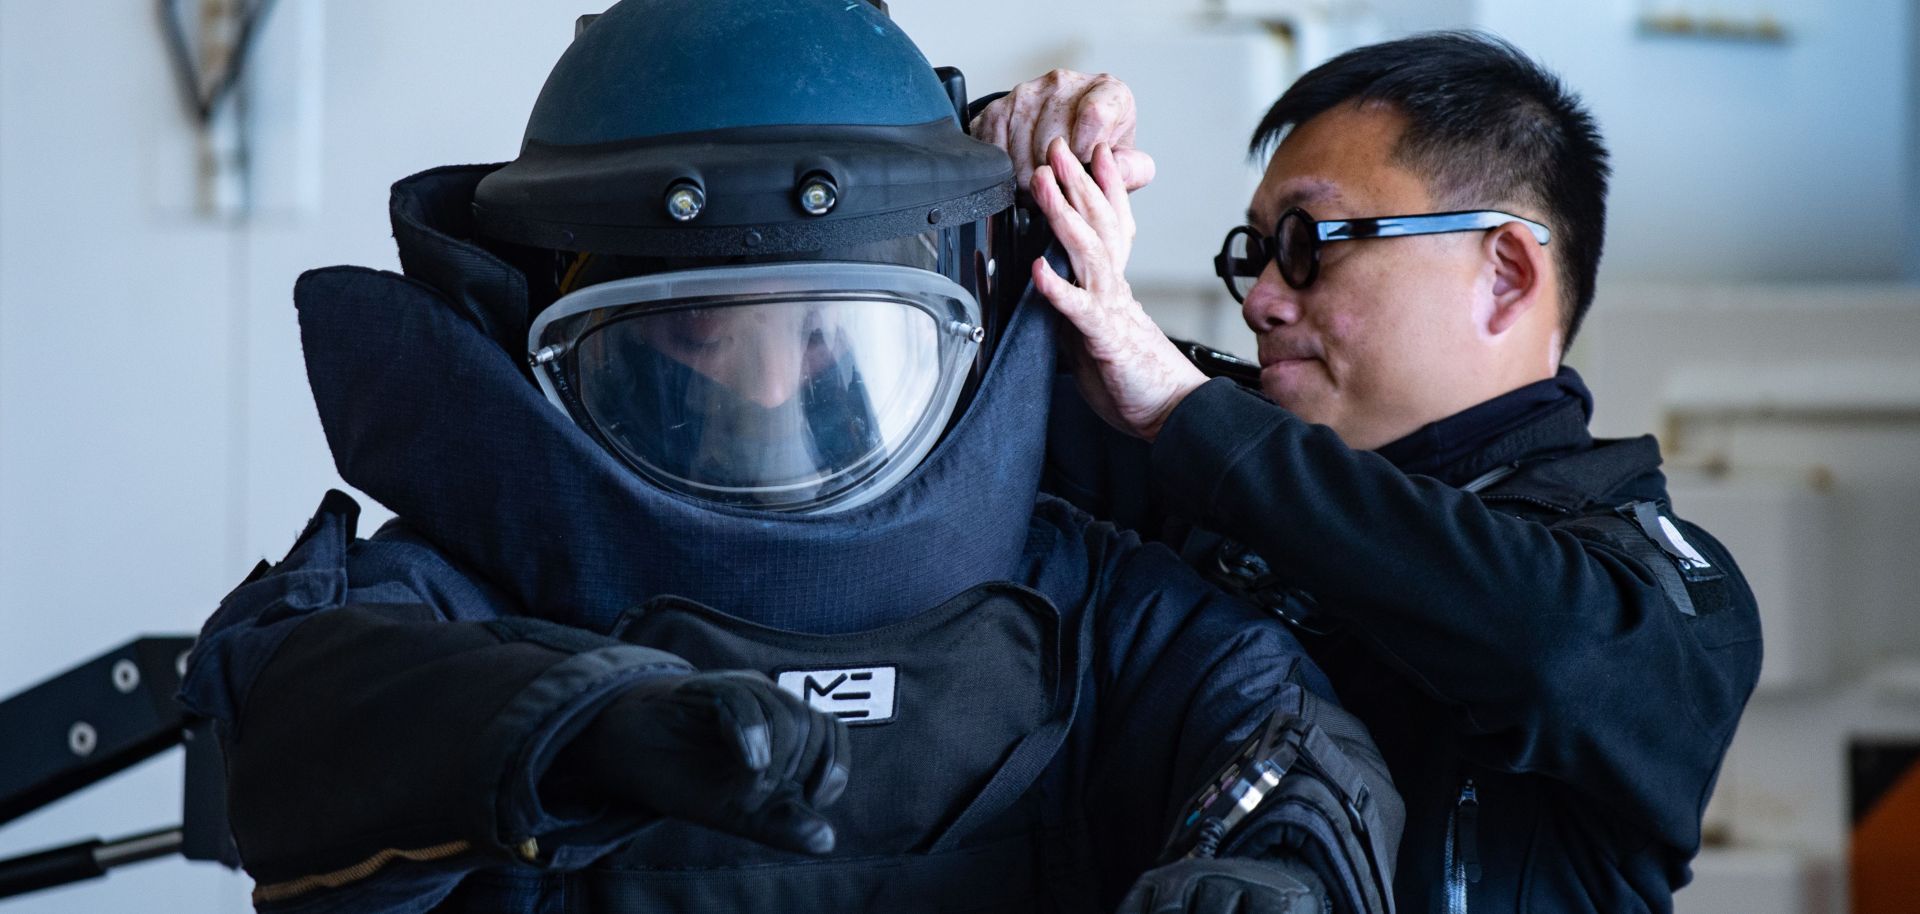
xmin=474 ymin=0 xmax=1018 ymax=513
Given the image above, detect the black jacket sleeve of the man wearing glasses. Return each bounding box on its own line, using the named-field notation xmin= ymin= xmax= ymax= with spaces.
xmin=1152 ymin=380 xmax=1759 ymax=851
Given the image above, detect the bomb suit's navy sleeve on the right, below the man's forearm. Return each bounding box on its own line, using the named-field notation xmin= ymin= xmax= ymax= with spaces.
xmin=1054 ymin=503 xmax=1404 ymax=910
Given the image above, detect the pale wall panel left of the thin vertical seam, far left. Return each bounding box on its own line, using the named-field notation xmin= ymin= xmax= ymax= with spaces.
xmin=0 ymin=4 xmax=244 ymax=912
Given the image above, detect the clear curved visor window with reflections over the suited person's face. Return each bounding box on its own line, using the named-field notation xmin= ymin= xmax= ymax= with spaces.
xmin=578 ymin=301 xmax=939 ymax=503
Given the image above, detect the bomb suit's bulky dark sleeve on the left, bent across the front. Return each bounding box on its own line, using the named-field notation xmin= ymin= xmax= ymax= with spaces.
xmin=180 ymin=492 xmax=689 ymax=912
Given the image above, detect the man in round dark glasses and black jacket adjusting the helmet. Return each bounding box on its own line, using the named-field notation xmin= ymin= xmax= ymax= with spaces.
xmin=973 ymin=35 xmax=1761 ymax=912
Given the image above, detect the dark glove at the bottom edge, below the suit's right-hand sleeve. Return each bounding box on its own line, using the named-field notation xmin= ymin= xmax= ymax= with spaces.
xmin=1119 ymin=856 xmax=1332 ymax=914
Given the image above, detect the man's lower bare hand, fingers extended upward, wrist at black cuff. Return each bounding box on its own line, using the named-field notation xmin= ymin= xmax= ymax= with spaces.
xmin=1033 ymin=140 xmax=1206 ymax=440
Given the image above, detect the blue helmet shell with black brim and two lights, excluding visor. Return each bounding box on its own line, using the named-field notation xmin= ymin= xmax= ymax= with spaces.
xmin=474 ymin=0 xmax=1014 ymax=257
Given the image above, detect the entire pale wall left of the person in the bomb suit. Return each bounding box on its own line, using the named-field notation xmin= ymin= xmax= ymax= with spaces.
xmin=0 ymin=0 xmax=584 ymax=912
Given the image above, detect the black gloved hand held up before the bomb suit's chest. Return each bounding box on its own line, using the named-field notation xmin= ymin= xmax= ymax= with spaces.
xmin=555 ymin=672 xmax=851 ymax=854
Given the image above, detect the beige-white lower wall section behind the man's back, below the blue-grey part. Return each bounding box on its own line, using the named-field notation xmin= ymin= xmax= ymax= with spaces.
xmin=1574 ymin=282 xmax=1920 ymax=914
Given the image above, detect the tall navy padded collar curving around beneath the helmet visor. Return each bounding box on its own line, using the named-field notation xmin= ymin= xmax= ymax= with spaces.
xmin=294 ymin=169 xmax=1054 ymax=634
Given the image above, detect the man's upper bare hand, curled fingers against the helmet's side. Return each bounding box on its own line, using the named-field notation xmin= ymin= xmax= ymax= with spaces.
xmin=968 ymin=69 xmax=1154 ymax=190
